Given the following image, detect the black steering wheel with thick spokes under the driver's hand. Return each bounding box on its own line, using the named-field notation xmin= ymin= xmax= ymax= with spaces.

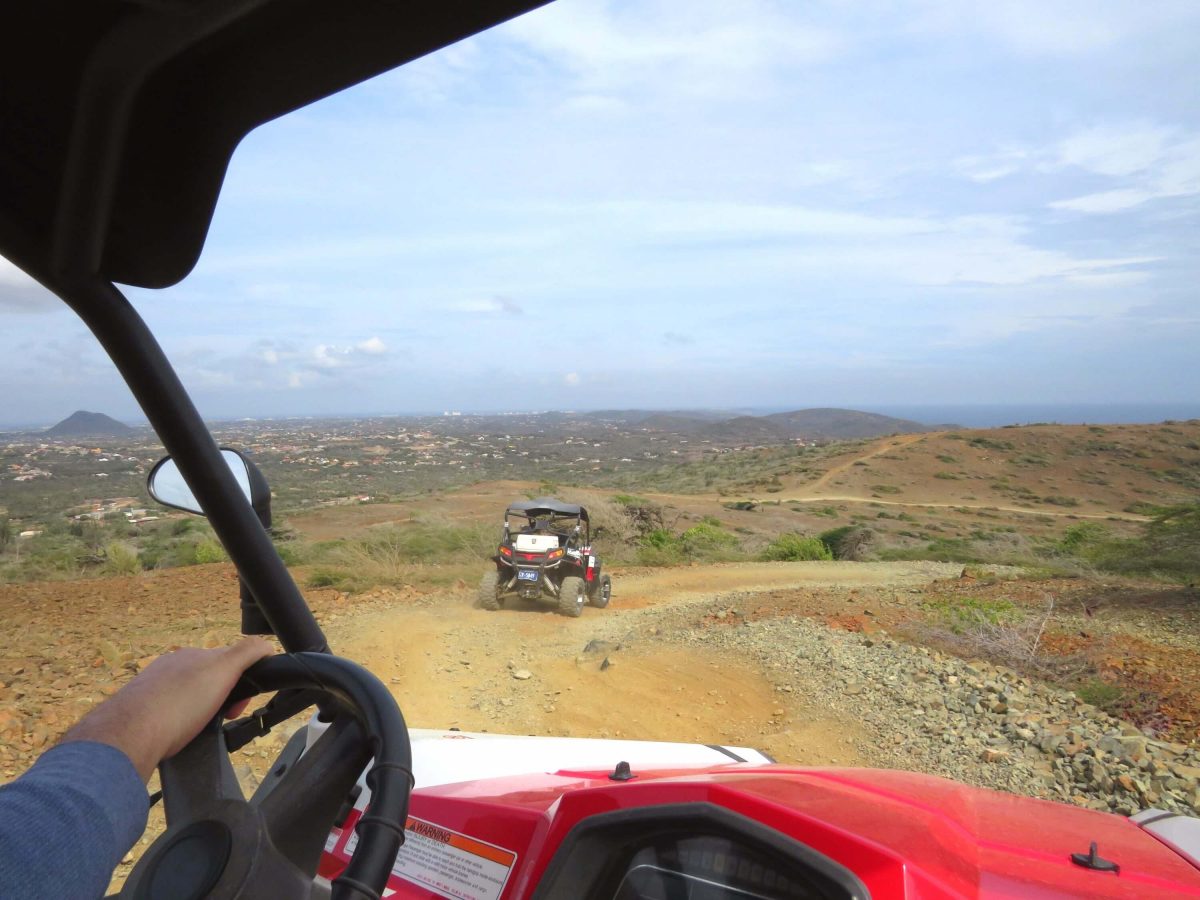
xmin=120 ymin=653 xmax=413 ymax=900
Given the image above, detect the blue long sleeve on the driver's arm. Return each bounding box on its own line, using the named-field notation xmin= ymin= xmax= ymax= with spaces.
xmin=0 ymin=740 xmax=150 ymax=900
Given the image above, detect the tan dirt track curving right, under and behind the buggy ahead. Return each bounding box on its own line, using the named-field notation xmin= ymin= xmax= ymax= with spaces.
xmin=328 ymin=563 xmax=953 ymax=764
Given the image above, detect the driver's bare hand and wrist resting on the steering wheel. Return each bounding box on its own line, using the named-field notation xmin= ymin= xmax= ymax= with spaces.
xmin=62 ymin=637 xmax=272 ymax=781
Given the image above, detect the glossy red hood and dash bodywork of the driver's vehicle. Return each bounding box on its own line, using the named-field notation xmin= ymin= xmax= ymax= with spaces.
xmin=322 ymin=736 xmax=1200 ymax=899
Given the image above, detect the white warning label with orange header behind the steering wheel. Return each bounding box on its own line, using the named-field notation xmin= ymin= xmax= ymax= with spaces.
xmin=344 ymin=816 xmax=517 ymax=900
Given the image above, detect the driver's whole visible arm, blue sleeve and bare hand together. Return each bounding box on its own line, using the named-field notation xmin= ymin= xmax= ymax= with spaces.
xmin=0 ymin=638 xmax=271 ymax=900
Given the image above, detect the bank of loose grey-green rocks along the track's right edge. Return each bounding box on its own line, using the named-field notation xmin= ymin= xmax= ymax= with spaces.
xmin=623 ymin=595 xmax=1200 ymax=815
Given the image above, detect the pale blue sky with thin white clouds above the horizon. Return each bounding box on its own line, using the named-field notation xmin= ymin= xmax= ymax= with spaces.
xmin=0 ymin=0 xmax=1200 ymax=424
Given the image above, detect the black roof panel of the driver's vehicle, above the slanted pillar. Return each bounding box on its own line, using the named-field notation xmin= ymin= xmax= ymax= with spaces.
xmin=0 ymin=0 xmax=546 ymax=288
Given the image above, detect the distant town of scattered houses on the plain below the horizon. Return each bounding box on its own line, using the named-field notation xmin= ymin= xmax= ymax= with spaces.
xmin=0 ymin=410 xmax=920 ymax=533
